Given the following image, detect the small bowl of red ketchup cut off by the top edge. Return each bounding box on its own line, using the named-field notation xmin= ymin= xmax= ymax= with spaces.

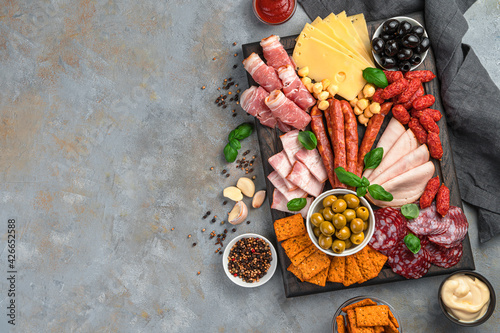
xmin=254 ymin=0 xmax=297 ymax=24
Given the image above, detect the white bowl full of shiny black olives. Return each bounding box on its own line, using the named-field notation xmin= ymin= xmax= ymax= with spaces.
xmin=372 ymin=16 xmax=430 ymax=72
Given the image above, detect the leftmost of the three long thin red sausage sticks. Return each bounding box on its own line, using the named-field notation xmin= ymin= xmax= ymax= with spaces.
xmin=311 ymin=105 xmax=335 ymax=187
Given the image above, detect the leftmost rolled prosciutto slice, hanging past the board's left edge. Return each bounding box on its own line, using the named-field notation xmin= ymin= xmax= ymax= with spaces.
xmin=240 ymin=86 xmax=276 ymax=128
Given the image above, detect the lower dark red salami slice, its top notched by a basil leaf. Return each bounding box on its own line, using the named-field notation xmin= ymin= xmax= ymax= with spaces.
xmin=387 ymin=241 xmax=431 ymax=279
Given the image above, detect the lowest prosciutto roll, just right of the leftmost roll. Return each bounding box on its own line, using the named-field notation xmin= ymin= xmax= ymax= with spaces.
xmin=265 ymin=90 xmax=311 ymax=130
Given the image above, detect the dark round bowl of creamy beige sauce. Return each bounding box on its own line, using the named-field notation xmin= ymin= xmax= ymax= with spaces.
xmin=438 ymin=271 xmax=496 ymax=326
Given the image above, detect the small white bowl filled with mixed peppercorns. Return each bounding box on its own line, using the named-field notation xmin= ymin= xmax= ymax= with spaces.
xmin=222 ymin=233 xmax=278 ymax=288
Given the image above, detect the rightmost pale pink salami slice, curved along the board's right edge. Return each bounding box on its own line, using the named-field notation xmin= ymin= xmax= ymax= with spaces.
xmin=429 ymin=206 xmax=469 ymax=248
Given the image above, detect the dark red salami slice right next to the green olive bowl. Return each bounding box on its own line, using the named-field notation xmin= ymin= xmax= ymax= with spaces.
xmin=369 ymin=207 xmax=406 ymax=250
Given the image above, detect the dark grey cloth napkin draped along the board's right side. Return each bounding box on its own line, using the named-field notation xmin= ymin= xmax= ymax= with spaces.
xmin=299 ymin=0 xmax=500 ymax=242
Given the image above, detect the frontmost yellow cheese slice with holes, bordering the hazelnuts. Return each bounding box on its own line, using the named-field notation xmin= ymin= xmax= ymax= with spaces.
xmin=293 ymin=33 xmax=366 ymax=100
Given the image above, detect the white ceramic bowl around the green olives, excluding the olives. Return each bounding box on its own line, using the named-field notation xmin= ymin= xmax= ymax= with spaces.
xmin=306 ymin=188 xmax=375 ymax=257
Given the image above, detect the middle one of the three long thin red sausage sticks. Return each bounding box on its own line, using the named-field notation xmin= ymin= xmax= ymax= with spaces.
xmin=329 ymin=99 xmax=347 ymax=188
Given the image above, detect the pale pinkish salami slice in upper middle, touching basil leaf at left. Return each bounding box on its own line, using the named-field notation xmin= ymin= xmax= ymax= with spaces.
xmin=406 ymin=203 xmax=451 ymax=235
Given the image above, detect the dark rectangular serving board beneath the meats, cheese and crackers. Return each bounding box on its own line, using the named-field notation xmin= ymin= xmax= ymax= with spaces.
xmin=242 ymin=13 xmax=475 ymax=297
